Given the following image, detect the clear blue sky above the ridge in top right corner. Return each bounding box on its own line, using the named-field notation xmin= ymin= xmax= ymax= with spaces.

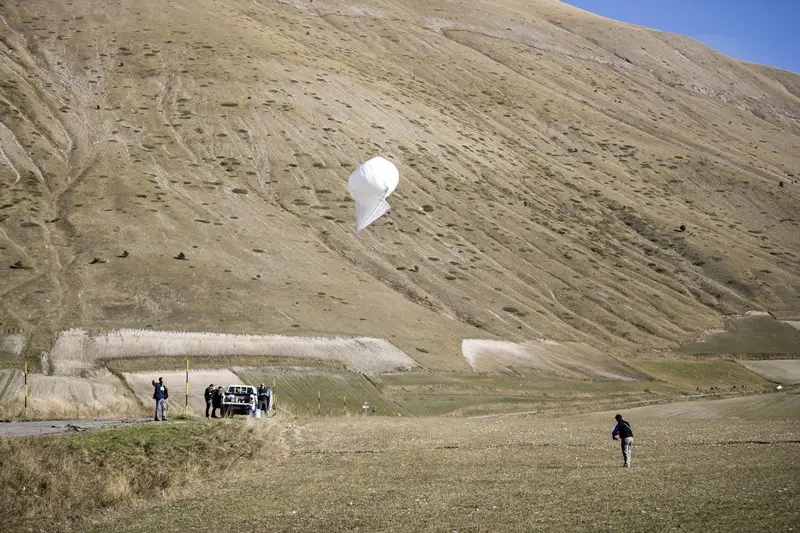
xmin=563 ymin=0 xmax=800 ymax=74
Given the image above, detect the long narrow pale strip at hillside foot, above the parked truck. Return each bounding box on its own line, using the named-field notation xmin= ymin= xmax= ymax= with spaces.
xmin=50 ymin=329 xmax=417 ymax=375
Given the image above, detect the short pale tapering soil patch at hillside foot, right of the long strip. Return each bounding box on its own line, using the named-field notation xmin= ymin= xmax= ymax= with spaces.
xmin=461 ymin=339 xmax=644 ymax=380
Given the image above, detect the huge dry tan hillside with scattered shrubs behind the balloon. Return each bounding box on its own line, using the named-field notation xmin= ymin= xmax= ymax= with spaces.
xmin=0 ymin=0 xmax=800 ymax=370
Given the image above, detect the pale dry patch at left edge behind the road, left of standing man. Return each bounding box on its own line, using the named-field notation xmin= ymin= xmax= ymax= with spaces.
xmin=0 ymin=370 xmax=141 ymax=418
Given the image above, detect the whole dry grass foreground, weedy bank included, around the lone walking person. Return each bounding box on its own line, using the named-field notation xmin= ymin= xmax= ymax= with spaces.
xmin=0 ymin=393 xmax=800 ymax=533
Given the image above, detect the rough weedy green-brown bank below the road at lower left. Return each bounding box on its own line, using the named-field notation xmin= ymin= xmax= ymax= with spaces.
xmin=0 ymin=419 xmax=278 ymax=531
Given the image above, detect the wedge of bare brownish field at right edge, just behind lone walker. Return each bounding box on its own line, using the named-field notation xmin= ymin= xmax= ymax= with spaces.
xmin=580 ymin=393 xmax=800 ymax=420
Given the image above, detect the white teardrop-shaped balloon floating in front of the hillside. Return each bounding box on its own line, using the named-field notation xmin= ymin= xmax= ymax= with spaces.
xmin=347 ymin=156 xmax=400 ymax=231
